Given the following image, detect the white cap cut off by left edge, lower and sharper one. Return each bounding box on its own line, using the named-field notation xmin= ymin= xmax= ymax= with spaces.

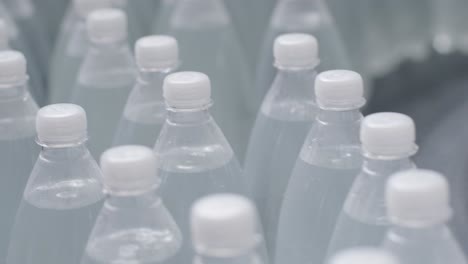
xmin=0 ymin=50 xmax=27 ymax=84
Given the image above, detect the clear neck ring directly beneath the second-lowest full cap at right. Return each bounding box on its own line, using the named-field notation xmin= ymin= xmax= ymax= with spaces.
xmin=363 ymin=157 xmax=415 ymax=177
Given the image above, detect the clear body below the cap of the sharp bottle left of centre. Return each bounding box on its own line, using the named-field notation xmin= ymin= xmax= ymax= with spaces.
xmin=155 ymin=107 xmax=245 ymax=263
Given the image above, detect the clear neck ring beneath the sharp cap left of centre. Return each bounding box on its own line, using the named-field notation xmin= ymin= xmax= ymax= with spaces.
xmin=167 ymin=105 xmax=212 ymax=125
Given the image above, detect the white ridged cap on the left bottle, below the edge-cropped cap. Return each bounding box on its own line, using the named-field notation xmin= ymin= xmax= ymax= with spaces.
xmin=36 ymin=104 xmax=87 ymax=146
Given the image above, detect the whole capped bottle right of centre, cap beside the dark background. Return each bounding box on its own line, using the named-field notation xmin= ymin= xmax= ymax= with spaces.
xmin=274 ymin=70 xmax=365 ymax=264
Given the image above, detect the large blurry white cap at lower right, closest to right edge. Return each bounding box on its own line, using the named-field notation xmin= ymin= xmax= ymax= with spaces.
xmin=386 ymin=169 xmax=452 ymax=228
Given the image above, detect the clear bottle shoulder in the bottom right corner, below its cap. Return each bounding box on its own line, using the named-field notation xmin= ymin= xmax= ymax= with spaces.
xmin=383 ymin=225 xmax=467 ymax=264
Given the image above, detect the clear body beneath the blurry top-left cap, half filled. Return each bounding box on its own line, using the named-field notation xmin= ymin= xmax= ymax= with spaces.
xmin=72 ymin=43 xmax=135 ymax=158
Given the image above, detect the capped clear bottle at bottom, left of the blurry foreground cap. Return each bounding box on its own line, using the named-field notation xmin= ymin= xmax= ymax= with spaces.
xmin=81 ymin=145 xmax=182 ymax=264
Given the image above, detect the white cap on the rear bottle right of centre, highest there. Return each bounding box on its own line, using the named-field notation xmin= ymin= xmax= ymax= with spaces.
xmin=274 ymin=33 xmax=320 ymax=68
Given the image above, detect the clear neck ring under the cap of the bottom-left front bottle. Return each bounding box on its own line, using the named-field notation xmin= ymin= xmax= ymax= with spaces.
xmin=106 ymin=189 xmax=161 ymax=209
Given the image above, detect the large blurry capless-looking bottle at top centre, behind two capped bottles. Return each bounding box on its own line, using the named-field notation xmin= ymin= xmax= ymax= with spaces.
xmin=156 ymin=0 xmax=254 ymax=160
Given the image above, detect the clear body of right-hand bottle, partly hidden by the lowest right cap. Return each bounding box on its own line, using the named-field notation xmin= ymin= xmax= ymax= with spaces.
xmin=328 ymin=157 xmax=415 ymax=257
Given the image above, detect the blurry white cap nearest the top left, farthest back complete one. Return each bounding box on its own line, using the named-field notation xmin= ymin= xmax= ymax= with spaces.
xmin=87 ymin=8 xmax=127 ymax=44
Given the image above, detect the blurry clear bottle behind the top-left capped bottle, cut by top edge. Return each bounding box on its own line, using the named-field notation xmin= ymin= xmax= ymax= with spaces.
xmin=49 ymin=0 xmax=111 ymax=103
